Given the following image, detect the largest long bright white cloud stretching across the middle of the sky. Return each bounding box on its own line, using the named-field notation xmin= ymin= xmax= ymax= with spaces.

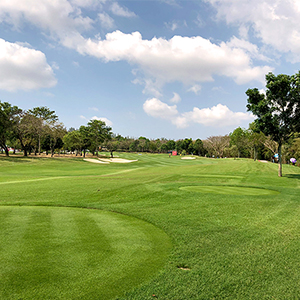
xmin=75 ymin=30 xmax=272 ymax=85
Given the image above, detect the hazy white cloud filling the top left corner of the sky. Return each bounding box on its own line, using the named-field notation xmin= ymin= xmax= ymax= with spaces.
xmin=0 ymin=0 xmax=94 ymax=50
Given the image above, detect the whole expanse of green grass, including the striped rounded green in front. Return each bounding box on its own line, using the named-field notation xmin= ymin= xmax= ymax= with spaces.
xmin=0 ymin=154 xmax=300 ymax=299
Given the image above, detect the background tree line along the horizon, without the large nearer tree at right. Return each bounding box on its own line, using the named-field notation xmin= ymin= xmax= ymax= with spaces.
xmin=0 ymin=102 xmax=300 ymax=164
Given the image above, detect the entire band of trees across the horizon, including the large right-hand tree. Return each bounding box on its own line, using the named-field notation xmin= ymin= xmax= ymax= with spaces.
xmin=0 ymin=72 xmax=300 ymax=176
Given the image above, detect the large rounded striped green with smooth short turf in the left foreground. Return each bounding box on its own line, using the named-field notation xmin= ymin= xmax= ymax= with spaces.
xmin=0 ymin=206 xmax=171 ymax=299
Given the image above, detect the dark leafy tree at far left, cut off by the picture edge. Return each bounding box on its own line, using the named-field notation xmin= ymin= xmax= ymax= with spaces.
xmin=0 ymin=101 xmax=22 ymax=156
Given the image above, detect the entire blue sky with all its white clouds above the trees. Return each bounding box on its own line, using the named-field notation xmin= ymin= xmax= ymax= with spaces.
xmin=0 ymin=0 xmax=300 ymax=139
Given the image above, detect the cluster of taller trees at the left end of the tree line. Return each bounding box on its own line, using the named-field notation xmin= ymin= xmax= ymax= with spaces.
xmin=0 ymin=101 xmax=112 ymax=156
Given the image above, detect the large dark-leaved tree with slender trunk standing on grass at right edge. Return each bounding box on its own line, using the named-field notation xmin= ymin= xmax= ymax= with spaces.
xmin=246 ymin=72 xmax=300 ymax=177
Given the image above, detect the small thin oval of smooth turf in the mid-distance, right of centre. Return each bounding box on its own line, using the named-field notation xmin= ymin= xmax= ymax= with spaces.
xmin=180 ymin=185 xmax=279 ymax=196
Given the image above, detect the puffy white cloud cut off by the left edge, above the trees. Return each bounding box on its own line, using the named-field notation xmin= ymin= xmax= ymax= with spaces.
xmin=0 ymin=39 xmax=57 ymax=91
